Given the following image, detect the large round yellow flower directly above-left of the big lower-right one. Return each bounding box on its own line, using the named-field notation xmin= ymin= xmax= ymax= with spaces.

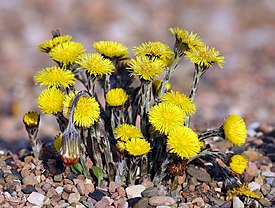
xmin=149 ymin=103 xmax=186 ymax=134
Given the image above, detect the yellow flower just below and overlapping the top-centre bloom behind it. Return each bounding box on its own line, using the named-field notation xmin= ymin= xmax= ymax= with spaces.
xmin=128 ymin=56 xmax=165 ymax=81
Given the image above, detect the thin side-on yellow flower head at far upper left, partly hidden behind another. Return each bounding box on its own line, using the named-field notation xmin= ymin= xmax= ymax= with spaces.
xmin=38 ymin=35 xmax=72 ymax=53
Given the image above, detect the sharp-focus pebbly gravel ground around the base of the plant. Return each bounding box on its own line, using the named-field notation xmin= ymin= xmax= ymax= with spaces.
xmin=0 ymin=123 xmax=275 ymax=208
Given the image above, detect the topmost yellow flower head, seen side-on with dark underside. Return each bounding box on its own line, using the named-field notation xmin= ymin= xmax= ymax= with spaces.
xmin=169 ymin=27 xmax=204 ymax=51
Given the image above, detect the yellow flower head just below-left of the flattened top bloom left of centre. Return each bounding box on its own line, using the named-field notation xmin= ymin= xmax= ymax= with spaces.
xmin=76 ymin=53 xmax=115 ymax=76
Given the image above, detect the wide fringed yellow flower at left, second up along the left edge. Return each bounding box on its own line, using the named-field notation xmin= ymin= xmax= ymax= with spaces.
xmin=34 ymin=66 xmax=75 ymax=88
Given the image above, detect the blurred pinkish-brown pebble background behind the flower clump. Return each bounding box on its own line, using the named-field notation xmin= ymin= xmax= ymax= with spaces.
xmin=0 ymin=0 xmax=275 ymax=148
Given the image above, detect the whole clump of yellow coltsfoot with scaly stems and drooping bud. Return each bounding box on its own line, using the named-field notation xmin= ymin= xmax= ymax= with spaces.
xmin=23 ymin=27 xmax=260 ymax=201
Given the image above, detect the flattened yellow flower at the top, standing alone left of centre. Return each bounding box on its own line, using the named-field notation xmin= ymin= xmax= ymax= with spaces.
xmin=93 ymin=41 xmax=129 ymax=59
